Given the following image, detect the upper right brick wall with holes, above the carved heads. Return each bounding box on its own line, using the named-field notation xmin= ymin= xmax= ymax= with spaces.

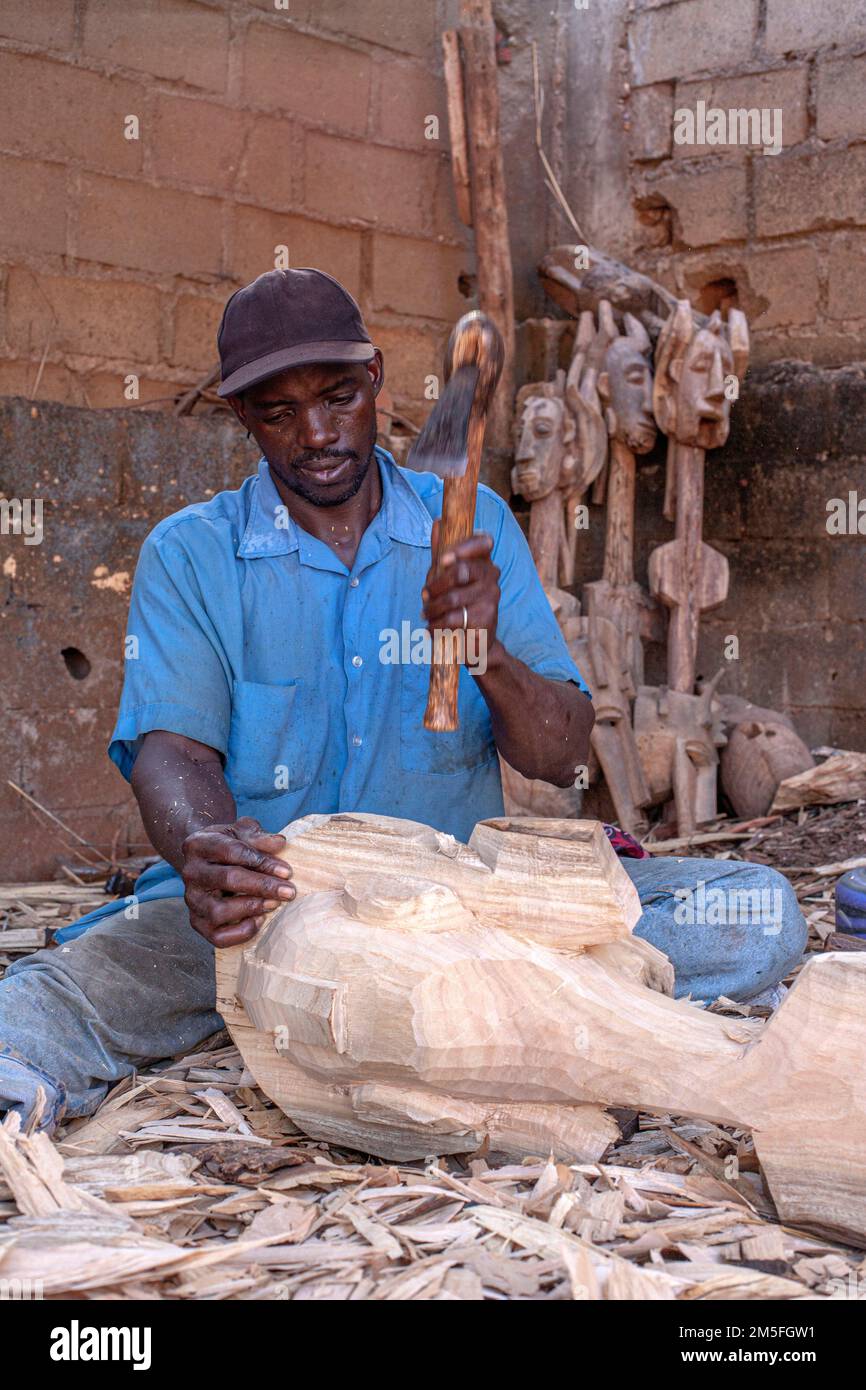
xmin=624 ymin=0 xmax=866 ymax=364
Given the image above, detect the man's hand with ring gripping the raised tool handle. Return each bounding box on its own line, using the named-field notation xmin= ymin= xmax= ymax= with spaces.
xmin=421 ymin=521 xmax=499 ymax=653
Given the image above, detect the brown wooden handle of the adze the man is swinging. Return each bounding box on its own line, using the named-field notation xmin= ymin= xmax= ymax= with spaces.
xmin=424 ymin=409 xmax=487 ymax=733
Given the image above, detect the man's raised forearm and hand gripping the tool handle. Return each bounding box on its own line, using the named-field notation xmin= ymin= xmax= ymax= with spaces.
xmin=421 ymin=521 xmax=595 ymax=787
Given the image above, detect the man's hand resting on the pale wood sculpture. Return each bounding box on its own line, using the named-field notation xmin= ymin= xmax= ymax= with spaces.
xmin=181 ymin=816 xmax=295 ymax=947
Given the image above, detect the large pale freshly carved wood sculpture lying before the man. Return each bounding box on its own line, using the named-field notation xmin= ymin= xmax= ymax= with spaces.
xmin=215 ymin=815 xmax=866 ymax=1243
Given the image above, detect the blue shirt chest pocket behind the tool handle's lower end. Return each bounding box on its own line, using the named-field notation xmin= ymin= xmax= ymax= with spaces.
xmin=400 ymin=663 xmax=496 ymax=776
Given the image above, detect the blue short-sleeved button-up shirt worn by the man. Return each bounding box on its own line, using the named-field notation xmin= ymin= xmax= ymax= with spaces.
xmin=57 ymin=448 xmax=587 ymax=938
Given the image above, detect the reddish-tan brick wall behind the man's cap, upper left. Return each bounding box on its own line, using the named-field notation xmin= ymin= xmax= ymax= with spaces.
xmin=0 ymin=0 xmax=473 ymax=417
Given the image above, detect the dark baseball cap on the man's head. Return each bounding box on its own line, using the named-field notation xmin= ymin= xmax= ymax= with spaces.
xmin=217 ymin=267 xmax=374 ymax=396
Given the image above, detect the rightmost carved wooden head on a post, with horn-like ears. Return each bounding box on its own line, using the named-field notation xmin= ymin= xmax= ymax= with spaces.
xmin=653 ymin=299 xmax=749 ymax=449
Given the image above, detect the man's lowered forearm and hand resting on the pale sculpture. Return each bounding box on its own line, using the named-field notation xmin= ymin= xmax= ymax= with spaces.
xmin=131 ymin=728 xmax=295 ymax=947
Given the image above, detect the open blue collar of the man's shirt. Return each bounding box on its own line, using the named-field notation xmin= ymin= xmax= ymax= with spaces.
xmin=238 ymin=445 xmax=432 ymax=560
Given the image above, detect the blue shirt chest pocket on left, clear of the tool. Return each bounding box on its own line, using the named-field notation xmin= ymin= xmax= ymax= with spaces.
xmin=225 ymin=680 xmax=313 ymax=801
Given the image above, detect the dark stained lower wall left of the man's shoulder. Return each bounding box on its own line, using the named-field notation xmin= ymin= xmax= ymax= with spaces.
xmin=0 ymin=399 xmax=256 ymax=881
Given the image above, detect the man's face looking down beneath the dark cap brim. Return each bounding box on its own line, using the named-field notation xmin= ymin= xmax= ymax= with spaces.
xmin=229 ymin=350 xmax=382 ymax=507
